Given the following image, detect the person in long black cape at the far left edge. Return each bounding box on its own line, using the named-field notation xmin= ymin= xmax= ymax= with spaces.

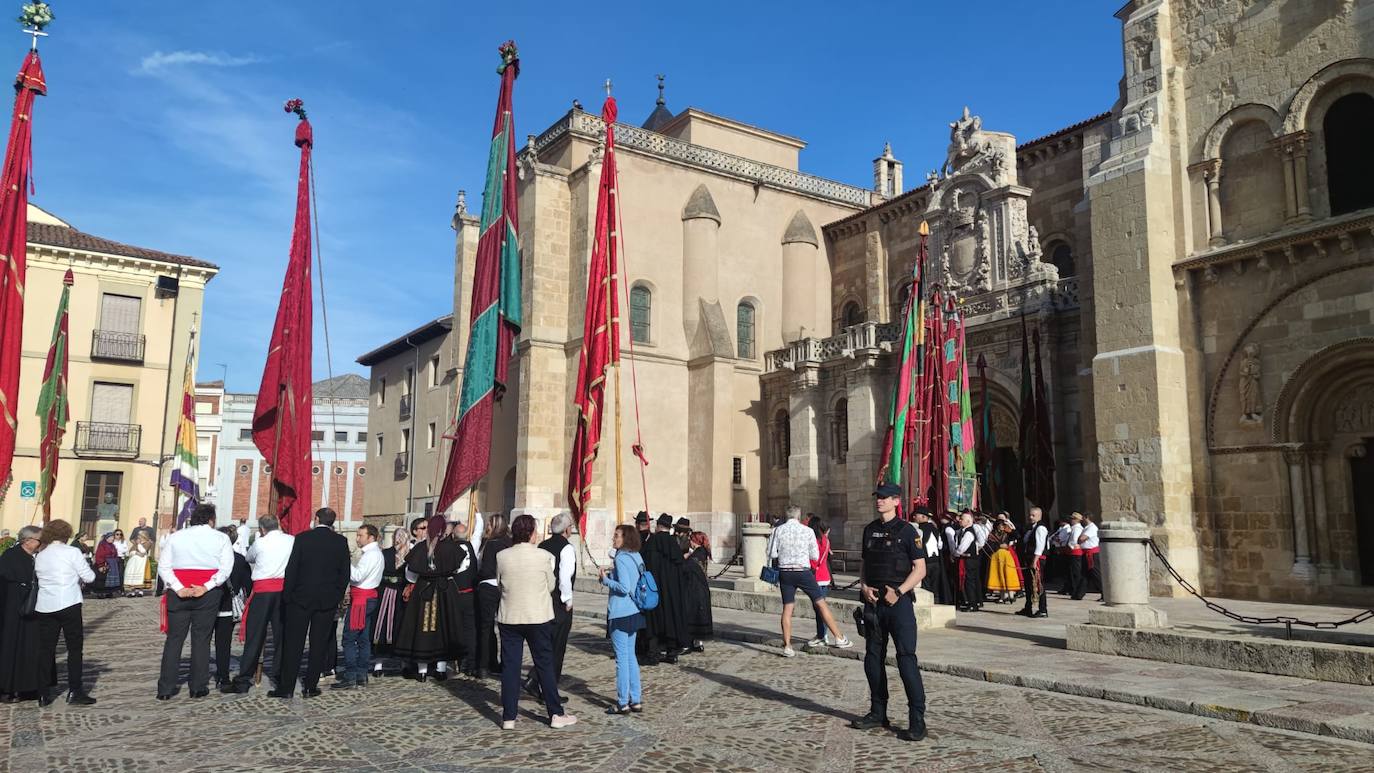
xmin=0 ymin=526 xmax=43 ymax=703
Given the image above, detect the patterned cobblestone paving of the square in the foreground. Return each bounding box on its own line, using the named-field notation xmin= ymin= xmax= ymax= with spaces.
xmin=10 ymin=599 xmax=1374 ymax=773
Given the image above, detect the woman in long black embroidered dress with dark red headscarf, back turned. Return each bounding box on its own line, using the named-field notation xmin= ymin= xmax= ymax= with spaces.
xmin=393 ymin=515 xmax=462 ymax=681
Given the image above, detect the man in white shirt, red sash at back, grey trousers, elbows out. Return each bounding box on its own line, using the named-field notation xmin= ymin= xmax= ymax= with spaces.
xmin=158 ymin=504 xmax=234 ymax=700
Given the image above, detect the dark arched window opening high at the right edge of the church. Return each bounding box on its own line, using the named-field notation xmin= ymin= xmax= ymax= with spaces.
xmin=1322 ymin=93 xmax=1374 ymax=214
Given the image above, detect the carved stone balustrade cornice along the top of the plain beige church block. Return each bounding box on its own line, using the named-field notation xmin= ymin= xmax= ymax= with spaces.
xmin=521 ymin=110 xmax=875 ymax=209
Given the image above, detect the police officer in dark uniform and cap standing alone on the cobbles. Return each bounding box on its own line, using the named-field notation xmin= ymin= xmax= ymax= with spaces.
xmin=851 ymin=483 xmax=926 ymax=741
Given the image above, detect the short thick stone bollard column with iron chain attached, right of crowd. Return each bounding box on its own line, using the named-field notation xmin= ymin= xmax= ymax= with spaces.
xmin=1088 ymin=520 xmax=1168 ymax=627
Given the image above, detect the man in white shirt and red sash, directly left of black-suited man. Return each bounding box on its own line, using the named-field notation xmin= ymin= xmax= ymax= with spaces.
xmin=234 ymin=515 xmax=295 ymax=692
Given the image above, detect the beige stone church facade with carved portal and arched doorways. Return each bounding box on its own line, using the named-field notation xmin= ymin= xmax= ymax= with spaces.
xmin=439 ymin=0 xmax=1374 ymax=604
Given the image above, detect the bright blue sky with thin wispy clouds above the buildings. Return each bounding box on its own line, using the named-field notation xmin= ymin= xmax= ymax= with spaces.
xmin=29 ymin=0 xmax=1121 ymax=391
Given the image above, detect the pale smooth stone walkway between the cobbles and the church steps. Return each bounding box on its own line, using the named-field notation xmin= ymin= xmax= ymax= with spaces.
xmin=577 ymin=592 xmax=1374 ymax=757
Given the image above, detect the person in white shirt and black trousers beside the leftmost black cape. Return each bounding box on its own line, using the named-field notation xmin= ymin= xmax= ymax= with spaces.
xmin=33 ymin=520 xmax=95 ymax=706
